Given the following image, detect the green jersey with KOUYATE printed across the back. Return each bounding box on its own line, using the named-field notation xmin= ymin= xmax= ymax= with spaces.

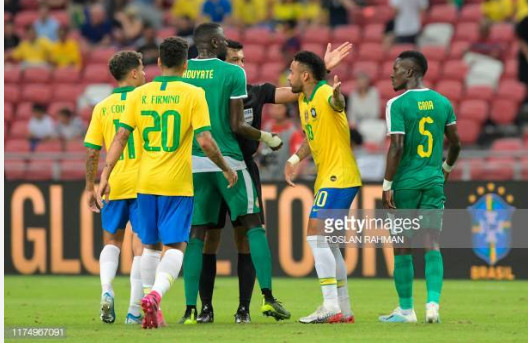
xmin=183 ymin=58 xmax=247 ymax=161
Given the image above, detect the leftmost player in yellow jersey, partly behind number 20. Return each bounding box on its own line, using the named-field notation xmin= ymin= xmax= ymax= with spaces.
xmin=84 ymin=51 xmax=145 ymax=324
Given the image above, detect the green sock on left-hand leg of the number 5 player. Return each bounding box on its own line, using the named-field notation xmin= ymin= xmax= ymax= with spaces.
xmin=394 ymin=255 xmax=414 ymax=310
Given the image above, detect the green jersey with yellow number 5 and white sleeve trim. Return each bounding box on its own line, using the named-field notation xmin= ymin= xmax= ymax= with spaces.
xmin=386 ymin=88 xmax=456 ymax=189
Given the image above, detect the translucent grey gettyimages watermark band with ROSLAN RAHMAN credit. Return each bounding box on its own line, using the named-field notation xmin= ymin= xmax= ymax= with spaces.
xmin=317 ymin=208 xmax=528 ymax=251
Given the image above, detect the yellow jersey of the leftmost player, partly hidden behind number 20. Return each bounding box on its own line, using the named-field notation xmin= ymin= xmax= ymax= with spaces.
xmin=84 ymin=87 xmax=141 ymax=200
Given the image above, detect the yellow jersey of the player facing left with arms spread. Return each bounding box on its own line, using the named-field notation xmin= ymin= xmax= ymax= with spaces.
xmin=299 ymin=81 xmax=361 ymax=193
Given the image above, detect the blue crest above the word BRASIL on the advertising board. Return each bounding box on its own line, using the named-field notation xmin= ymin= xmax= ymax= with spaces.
xmin=468 ymin=183 xmax=515 ymax=266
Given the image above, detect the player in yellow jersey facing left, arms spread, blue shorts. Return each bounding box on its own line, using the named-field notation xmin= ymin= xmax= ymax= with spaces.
xmin=284 ymin=51 xmax=361 ymax=323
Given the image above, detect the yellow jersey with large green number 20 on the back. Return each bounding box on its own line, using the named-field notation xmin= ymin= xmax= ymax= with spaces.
xmin=120 ymin=76 xmax=211 ymax=196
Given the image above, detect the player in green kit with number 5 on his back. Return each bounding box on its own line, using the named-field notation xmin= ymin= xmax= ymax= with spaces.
xmin=379 ymin=51 xmax=461 ymax=323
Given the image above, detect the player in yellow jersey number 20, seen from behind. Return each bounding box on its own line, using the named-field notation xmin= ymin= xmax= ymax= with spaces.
xmin=97 ymin=37 xmax=237 ymax=328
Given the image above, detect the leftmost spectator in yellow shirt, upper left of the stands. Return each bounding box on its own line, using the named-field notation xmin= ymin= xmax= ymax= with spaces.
xmin=9 ymin=26 xmax=51 ymax=68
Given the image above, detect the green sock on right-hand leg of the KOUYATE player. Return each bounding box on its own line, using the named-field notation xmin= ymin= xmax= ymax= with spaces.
xmin=247 ymin=226 xmax=271 ymax=291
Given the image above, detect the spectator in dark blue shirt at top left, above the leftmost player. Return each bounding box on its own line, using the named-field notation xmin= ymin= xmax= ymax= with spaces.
xmin=81 ymin=4 xmax=112 ymax=44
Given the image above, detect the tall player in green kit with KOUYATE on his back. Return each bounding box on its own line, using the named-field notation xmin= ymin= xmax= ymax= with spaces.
xmin=180 ymin=23 xmax=290 ymax=324
